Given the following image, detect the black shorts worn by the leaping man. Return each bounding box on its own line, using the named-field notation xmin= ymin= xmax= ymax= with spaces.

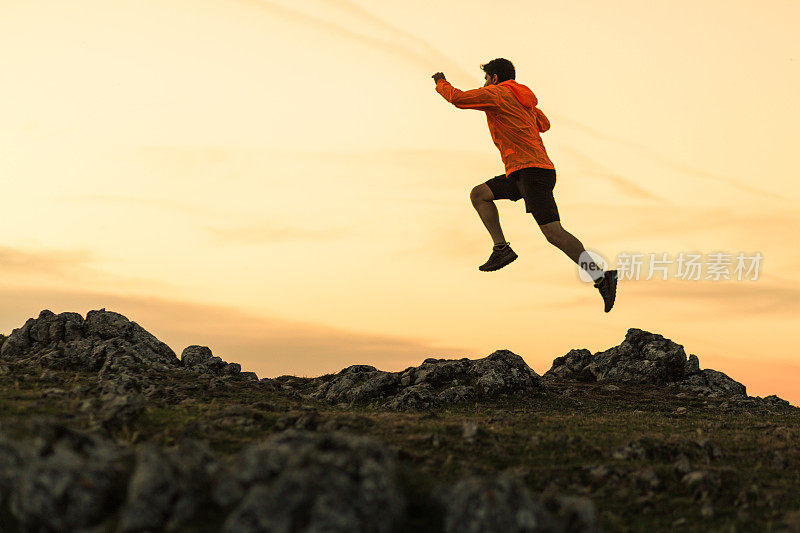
xmin=486 ymin=167 xmax=560 ymax=226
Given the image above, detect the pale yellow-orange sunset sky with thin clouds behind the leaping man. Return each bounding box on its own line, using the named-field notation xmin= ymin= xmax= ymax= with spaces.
xmin=0 ymin=0 xmax=800 ymax=405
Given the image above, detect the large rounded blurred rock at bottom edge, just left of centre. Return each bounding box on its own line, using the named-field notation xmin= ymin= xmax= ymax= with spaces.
xmin=216 ymin=430 xmax=406 ymax=533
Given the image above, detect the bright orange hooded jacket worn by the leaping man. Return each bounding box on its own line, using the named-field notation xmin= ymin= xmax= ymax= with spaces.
xmin=436 ymin=79 xmax=555 ymax=175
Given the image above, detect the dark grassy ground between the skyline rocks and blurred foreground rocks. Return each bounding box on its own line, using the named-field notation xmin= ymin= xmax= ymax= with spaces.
xmin=0 ymin=365 xmax=800 ymax=531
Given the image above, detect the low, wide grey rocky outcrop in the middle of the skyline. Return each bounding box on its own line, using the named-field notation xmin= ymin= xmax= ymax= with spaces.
xmin=312 ymin=350 xmax=544 ymax=409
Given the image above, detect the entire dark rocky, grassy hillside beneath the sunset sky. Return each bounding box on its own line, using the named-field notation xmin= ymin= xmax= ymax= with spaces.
xmin=0 ymin=309 xmax=800 ymax=533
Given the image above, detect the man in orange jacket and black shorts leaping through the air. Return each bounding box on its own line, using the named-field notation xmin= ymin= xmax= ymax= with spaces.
xmin=433 ymin=58 xmax=617 ymax=313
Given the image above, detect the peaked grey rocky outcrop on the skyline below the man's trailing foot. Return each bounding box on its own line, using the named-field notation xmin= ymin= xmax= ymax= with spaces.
xmin=544 ymin=328 xmax=747 ymax=397
